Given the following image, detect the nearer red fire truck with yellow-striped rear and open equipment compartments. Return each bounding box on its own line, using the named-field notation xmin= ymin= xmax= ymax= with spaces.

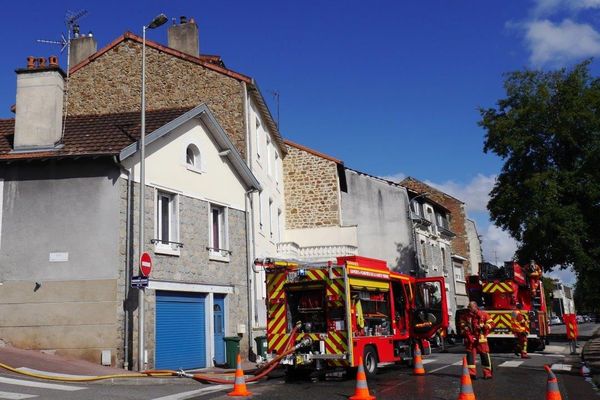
xmin=255 ymin=256 xmax=448 ymax=375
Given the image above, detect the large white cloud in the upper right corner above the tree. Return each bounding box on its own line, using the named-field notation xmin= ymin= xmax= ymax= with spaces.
xmin=524 ymin=19 xmax=600 ymax=66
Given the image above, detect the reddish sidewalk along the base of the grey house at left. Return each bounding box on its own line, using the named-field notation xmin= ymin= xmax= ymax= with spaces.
xmin=0 ymin=343 xmax=256 ymax=384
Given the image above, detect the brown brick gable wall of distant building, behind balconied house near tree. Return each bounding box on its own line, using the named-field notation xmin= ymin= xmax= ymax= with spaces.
xmin=400 ymin=177 xmax=471 ymax=274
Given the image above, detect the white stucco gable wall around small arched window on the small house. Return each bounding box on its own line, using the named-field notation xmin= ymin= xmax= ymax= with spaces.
xmin=123 ymin=119 xmax=246 ymax=210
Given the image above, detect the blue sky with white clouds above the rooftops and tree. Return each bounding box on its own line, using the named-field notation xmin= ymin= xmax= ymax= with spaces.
xmin=0 ymin=0 xmax=600 ymax=286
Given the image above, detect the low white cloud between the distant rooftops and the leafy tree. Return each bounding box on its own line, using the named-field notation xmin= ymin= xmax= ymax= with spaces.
xmin=425 ymin=174 xmax=496 ymax=212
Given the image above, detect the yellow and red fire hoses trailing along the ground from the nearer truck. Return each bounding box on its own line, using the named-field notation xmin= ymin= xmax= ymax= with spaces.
xmin=0 ymin=327 xmax=311 ymax=384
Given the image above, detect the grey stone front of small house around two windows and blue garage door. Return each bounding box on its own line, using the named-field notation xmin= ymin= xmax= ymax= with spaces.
xmin=118 ymin=179 xmax=248 ymax=365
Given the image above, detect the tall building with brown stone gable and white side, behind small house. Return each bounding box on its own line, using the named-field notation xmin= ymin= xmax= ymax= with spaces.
xmin=67 ymin=17 xmax=286 ymax=346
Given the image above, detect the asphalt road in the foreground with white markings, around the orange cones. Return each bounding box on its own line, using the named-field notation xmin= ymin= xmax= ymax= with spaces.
xmin=0 ymin=343 xmax=600 ymax=400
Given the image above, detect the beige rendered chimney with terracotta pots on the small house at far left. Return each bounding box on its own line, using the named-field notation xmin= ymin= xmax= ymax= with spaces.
xmin=14 ymin=56 xmax=65 ymax=150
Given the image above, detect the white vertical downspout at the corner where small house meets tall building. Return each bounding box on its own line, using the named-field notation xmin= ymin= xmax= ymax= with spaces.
xmin=242 ymin=82 xmax=256 ymax=353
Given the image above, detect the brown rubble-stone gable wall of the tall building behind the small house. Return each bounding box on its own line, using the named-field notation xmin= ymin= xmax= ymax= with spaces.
xmin=68 ymin=40 xmax=246 ymax=159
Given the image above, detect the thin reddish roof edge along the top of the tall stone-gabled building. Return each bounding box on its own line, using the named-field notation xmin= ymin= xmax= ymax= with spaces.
xmin=70 ymin=32 xmax=287 ymax=154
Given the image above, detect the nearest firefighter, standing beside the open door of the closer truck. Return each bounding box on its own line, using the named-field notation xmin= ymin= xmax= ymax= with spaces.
xmin=460 ymin=301 xmax=494 ymax=379
